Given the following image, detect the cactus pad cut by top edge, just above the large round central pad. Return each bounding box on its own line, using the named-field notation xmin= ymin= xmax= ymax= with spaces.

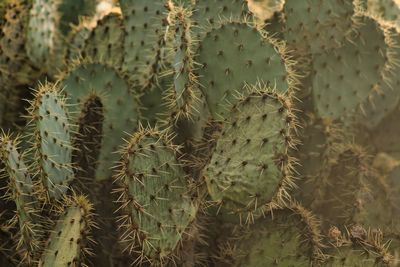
xmin=193 ymin=0 xmax=249 ymax=40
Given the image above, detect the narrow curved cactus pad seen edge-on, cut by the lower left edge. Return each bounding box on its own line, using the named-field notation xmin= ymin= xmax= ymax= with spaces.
xmin=0 ymin=134 xmax=40 ymax=264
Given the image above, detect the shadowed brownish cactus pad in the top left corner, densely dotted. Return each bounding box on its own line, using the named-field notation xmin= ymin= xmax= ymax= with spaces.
xmin=0 ymin=0 xmax=40 ymax=129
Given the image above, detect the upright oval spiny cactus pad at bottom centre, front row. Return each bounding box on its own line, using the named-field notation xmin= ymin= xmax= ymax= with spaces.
xmin=116 ymin=129 xmax=197 ymax=265
